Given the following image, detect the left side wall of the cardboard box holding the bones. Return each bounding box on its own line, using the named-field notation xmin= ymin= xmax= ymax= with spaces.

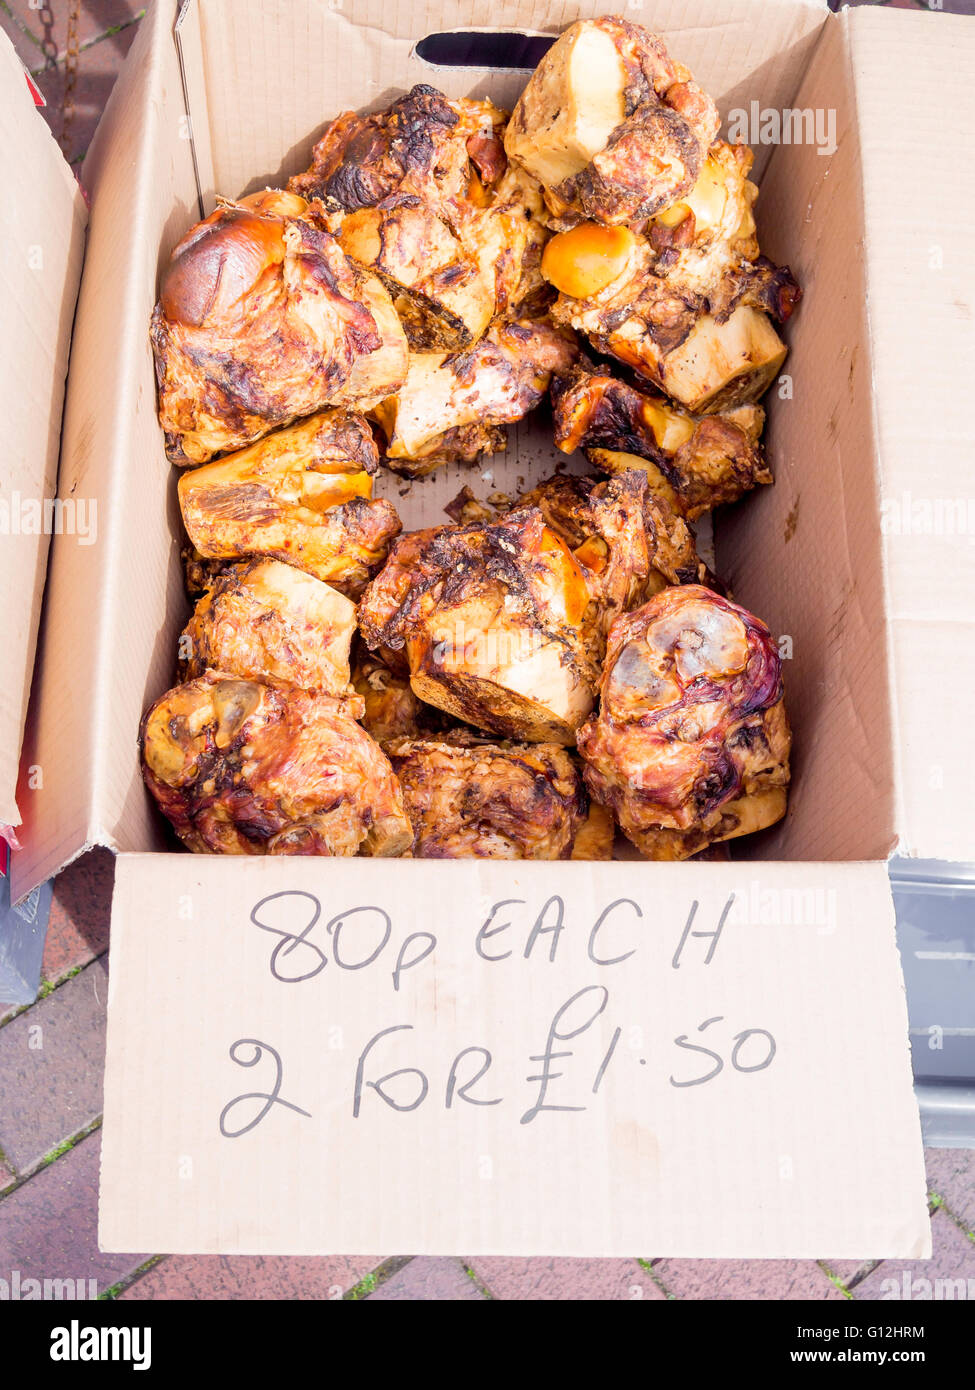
xmin=15 ymin=4 xmax=198 ymax=895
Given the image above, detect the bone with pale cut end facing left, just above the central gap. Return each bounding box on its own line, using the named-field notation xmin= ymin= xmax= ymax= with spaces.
xmin=374 ymin=320 xmax=579 ymax=478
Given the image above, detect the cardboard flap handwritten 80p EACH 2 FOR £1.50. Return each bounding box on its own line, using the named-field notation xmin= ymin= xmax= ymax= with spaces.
xmin=100 ymin=855 xmax=930 ymax=1258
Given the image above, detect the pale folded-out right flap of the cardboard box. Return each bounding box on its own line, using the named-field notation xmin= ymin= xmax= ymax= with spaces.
xmin=850 ymin=11 xmax=975 ymax=860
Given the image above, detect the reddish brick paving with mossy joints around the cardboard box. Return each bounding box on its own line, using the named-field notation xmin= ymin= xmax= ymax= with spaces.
xmin=0 ymin=0 xmax=975 ymax=1301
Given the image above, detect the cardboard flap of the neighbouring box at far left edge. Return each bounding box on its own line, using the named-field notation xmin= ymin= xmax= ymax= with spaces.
xmin=0 ymin=33 xmax=85 ymax=826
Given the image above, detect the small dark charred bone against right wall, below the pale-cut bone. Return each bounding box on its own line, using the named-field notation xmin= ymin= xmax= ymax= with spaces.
xmin=552 ymin=367 xmax=772 ymax=521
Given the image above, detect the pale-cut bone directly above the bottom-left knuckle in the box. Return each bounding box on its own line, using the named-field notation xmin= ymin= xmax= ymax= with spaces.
xmin=179 ymin=560 xmax=356 ymax=698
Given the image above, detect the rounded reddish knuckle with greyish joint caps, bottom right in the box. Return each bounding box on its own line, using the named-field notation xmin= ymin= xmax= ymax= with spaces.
xmin=579 ymin=585 xmax=790 ymax=859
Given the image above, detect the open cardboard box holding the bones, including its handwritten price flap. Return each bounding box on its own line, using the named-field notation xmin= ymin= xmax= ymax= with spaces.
xmin=7 ymin=0 xmax=975 ymax=1258
